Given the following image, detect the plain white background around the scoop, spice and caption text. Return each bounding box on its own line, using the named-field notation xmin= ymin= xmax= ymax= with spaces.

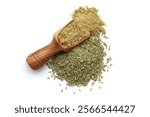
xmin=0 ymin=0 xmax=150 ymax=117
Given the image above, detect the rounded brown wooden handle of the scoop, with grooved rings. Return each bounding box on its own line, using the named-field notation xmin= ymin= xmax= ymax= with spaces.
xmin=26 ymin=38 xmax=63 ymax=70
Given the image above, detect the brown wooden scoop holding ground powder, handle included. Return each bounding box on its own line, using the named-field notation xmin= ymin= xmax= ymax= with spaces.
xmin=26 ymin=21 xmax=90 ymax=70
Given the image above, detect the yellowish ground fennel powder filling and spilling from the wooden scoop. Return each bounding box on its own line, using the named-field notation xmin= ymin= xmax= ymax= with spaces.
xmin=58 ymin=7 xmax=105 ymax=46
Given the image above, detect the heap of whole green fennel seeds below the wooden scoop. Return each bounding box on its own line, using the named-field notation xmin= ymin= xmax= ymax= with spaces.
xmin=47 ymin=36 xmax=106 ymax=86
